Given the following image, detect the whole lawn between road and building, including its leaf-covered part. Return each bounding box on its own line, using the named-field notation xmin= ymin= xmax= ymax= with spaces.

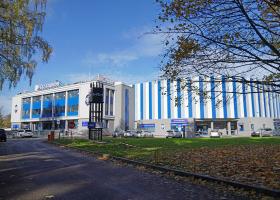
xmin=56 ymin=137 xmax=280 ymax=189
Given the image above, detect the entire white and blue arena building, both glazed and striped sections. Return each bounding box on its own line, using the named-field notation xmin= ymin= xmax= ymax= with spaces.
xmin=11 ymin=77 xmax=280 ymax=136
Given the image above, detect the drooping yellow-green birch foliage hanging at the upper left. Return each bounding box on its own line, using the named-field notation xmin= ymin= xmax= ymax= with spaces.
xmin=0 ymin=0 xmax=52 ymax=90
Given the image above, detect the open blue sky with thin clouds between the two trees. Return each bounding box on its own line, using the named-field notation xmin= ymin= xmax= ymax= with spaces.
xmin=0 ymin=0 xmax=164 ymax=114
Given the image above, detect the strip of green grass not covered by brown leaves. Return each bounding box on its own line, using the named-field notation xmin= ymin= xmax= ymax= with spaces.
xmin=56 ymin=137 xmax=280 ymax=160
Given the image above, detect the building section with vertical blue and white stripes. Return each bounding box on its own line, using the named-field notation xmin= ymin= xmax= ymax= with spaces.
xmin=134 ymin=77 xmax=280 ymax=135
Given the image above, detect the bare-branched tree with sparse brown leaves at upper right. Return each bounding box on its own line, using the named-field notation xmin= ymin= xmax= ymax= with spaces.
xmin=155 ymin=0 xmax=280 ymax=87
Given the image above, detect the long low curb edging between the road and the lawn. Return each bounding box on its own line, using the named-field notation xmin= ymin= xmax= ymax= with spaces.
xmin=50 ymin=142 xmax=280 ymax=197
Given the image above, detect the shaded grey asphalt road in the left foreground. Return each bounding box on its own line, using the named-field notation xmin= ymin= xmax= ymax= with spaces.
xmin=0 ymin=139 xmax=245 ymax=200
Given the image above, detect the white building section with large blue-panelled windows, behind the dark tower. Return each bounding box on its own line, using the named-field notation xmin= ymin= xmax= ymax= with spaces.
xmin=11 ymin=78 xmax=134 ymax=134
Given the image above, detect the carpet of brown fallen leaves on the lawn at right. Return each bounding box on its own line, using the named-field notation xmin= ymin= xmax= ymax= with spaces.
xmin=155 ymin=145 xmax=280 ymax=189
